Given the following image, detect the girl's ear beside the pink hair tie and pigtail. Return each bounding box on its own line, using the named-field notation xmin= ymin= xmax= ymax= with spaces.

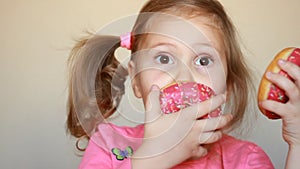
xmin=128 ymin=60 xmax=142 ymax=98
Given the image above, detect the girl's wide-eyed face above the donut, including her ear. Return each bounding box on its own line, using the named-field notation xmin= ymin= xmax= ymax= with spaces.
xmin=129 ymin=17 xmax=227 ymax=103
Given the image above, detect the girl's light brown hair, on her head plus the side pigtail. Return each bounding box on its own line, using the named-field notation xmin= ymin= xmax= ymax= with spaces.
xmin=67 ymin=0 xmax=253 ymax=144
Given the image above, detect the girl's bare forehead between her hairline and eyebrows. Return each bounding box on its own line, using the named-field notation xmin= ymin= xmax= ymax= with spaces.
xmin=142 ymin=16 xmax=222 ymax=51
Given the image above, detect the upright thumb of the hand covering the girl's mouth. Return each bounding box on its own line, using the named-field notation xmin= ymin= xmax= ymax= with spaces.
xmin=145 ymin=85 xmax=162 ymax=123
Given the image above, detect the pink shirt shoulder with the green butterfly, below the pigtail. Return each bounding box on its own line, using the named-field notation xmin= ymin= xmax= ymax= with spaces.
xmin=79 ymin=123 xmax=144 ymax=169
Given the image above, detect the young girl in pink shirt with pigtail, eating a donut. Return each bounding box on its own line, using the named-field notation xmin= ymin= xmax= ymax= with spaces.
xmin=68 ymin=0 xmax=300 ymax=169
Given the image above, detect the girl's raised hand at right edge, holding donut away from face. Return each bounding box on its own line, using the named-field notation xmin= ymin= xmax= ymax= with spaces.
xmin=260 ymin=60 xmax=300 ymax=147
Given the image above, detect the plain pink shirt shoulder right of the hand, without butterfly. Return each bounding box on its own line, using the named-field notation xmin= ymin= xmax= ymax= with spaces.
xmin=172 ymin=135 xmax=274 ymax=169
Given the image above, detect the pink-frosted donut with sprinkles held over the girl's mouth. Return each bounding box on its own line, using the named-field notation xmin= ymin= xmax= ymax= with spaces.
xmin=160 ymin=82 xmax=221 ymax=118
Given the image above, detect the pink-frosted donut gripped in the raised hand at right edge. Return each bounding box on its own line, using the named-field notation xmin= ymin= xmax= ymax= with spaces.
xmin=258 ymin=47 xmax=300 ymax=119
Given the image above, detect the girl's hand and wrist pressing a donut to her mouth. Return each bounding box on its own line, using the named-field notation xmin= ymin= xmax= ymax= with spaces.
xmin=132 ymin=86 xmax=232 ymax=168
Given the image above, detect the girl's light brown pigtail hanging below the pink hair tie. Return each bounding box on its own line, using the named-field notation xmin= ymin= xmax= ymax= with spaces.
xmin=67 ymin=34 xmax=128 ymax=141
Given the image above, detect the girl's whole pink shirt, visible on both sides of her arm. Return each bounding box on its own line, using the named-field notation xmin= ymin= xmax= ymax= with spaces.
xmin=79 ymin=123 xmax=274 ymax=169
